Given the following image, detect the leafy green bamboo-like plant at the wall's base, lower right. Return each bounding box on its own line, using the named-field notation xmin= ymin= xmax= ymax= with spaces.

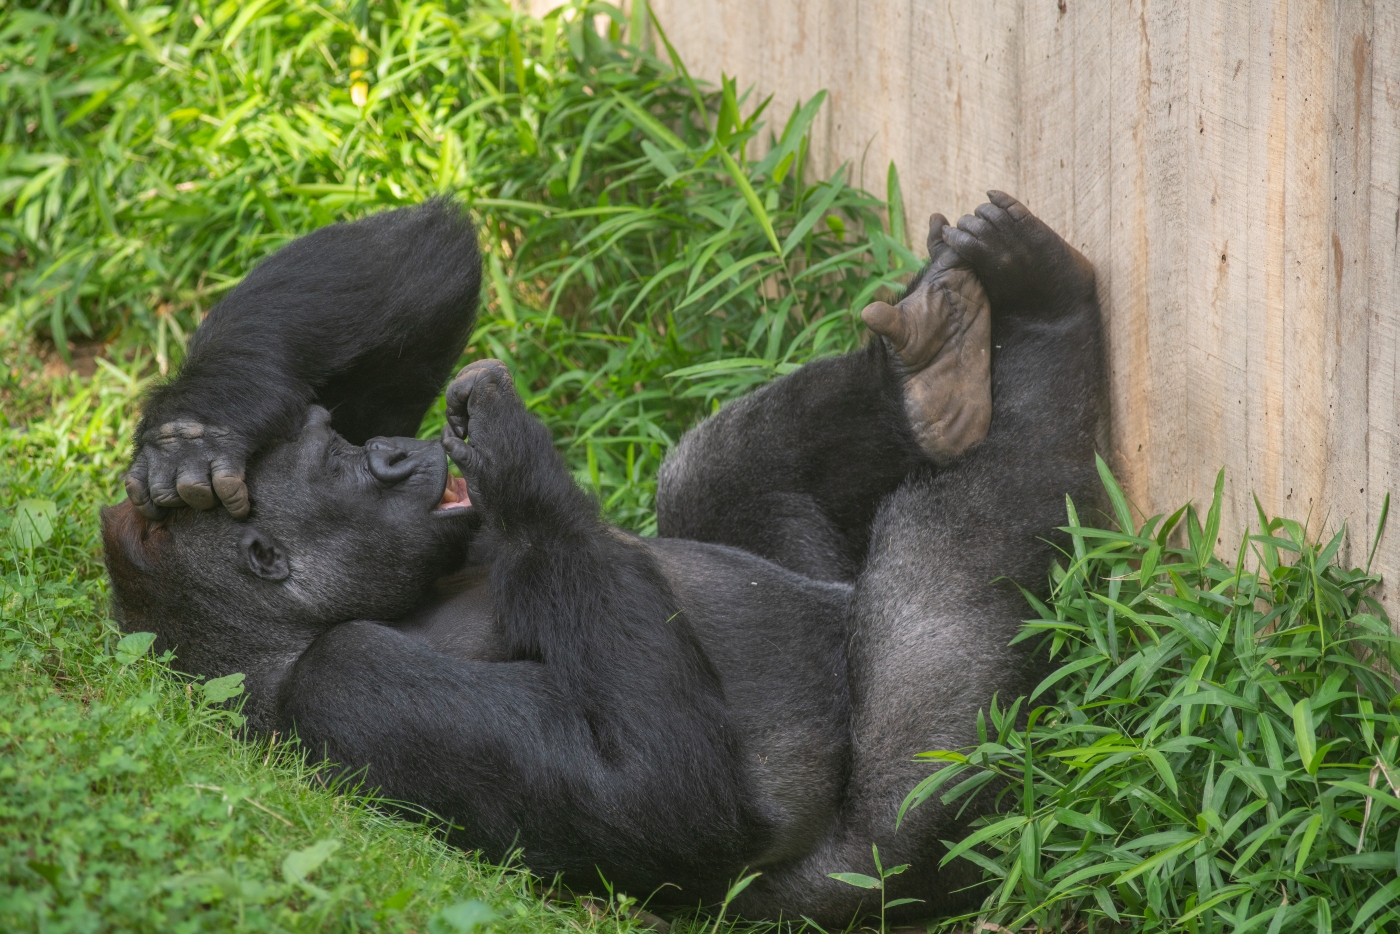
xmin=902 ymin=461 xmax=1400 ymax=934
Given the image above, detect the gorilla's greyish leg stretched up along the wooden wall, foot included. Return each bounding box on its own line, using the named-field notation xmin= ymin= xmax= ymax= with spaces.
xmin=739 ymin=192 xmax=1103 ymax=924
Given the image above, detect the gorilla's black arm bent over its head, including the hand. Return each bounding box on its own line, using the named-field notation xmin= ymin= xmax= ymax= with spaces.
xmin=126 ymin=199 xmax=482 ymax=518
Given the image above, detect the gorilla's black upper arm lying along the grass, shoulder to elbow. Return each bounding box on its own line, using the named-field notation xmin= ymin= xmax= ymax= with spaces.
xmin=283 ymin=621 xmax=760 ymax=902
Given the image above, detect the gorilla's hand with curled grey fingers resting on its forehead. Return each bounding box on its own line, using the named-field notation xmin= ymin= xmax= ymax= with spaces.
xmin=126 ymin=419 xmax=249 ymax=520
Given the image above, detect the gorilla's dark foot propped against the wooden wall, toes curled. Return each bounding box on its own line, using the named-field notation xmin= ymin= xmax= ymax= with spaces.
xmin=942 ymin=190 xmax=1095 ymax=318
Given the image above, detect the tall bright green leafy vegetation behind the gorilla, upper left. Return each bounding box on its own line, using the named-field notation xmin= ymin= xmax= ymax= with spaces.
xmin=0 ymin=0 xmax=917 ymax=529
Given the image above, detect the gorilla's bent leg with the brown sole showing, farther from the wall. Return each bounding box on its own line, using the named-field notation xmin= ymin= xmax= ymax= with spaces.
xmin=657 ymin=221 xmax=991 ymax=581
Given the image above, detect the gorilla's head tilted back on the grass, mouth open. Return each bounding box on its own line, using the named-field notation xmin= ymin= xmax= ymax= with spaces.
xmin=102 ymin=406 xmax=475 ymax=694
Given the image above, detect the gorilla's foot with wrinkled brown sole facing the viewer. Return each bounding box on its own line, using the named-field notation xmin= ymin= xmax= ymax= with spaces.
xmin=861 ymin=214 xmax=991 ymax=465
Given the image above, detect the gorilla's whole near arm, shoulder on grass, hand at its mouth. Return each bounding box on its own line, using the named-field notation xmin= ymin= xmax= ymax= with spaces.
xmin=283 ymin=360 xmax=767 ymax=900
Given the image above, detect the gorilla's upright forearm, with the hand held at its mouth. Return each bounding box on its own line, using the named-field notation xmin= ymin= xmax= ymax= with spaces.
xmin=444 ymin=360 xmax=734 ymax=759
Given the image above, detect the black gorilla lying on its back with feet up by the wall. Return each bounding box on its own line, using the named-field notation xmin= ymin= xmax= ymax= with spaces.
xmin=102 ymin=192 xmax=1102 ymax=927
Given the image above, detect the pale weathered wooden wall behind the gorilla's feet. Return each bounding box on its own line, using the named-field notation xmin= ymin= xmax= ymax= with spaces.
xmin=651 ymin=0 xmax=1400 ymax=604
